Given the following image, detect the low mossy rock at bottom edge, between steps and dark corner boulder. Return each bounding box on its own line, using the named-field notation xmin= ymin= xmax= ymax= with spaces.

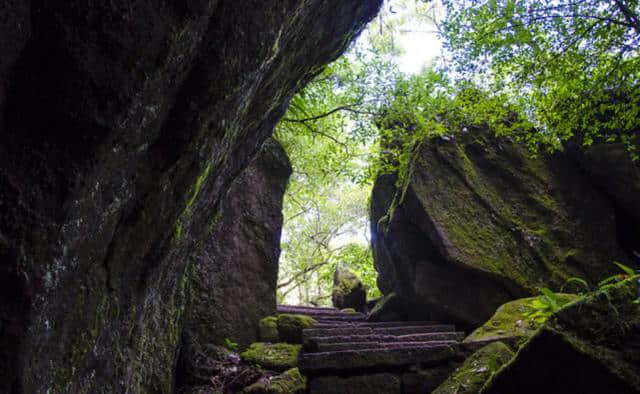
xmin=433 ymin=342 xmax=514 ymax=394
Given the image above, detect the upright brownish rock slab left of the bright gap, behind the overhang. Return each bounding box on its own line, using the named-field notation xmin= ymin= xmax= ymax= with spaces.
xmin=185 ymin=139 xmax=291 ymax=348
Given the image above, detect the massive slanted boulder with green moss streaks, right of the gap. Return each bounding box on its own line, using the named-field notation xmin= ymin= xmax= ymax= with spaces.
xmin=371 ymin=129 xmax=640 ymax=327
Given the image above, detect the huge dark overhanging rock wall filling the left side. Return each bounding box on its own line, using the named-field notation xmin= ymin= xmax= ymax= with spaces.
xmin=0 ymin=0 xmax=380 ymax=393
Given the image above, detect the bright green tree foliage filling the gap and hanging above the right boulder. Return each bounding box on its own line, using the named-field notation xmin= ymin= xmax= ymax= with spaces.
xmin=276 ymin=0 xmax=640 ymax=304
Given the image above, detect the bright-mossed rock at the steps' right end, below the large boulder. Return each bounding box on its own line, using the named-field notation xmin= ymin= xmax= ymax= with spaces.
xmin=464 ymin=293 xmax=580 ymax=342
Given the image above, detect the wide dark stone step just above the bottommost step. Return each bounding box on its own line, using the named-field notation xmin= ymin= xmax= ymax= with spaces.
xmin=298 ymin=343 xmax=458 ymax=376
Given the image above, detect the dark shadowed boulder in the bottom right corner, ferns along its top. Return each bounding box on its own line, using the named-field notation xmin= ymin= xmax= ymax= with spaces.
xmin=481 ymin=278 xmax=640 ymax=394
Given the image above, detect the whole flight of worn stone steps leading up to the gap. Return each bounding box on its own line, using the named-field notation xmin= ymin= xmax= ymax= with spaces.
xmin=278 ymin=305 xmax=484 ymax=394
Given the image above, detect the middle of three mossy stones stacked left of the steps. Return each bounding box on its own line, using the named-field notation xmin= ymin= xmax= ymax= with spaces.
xmin=240 ymin=342 xmax=301 ymax=372
